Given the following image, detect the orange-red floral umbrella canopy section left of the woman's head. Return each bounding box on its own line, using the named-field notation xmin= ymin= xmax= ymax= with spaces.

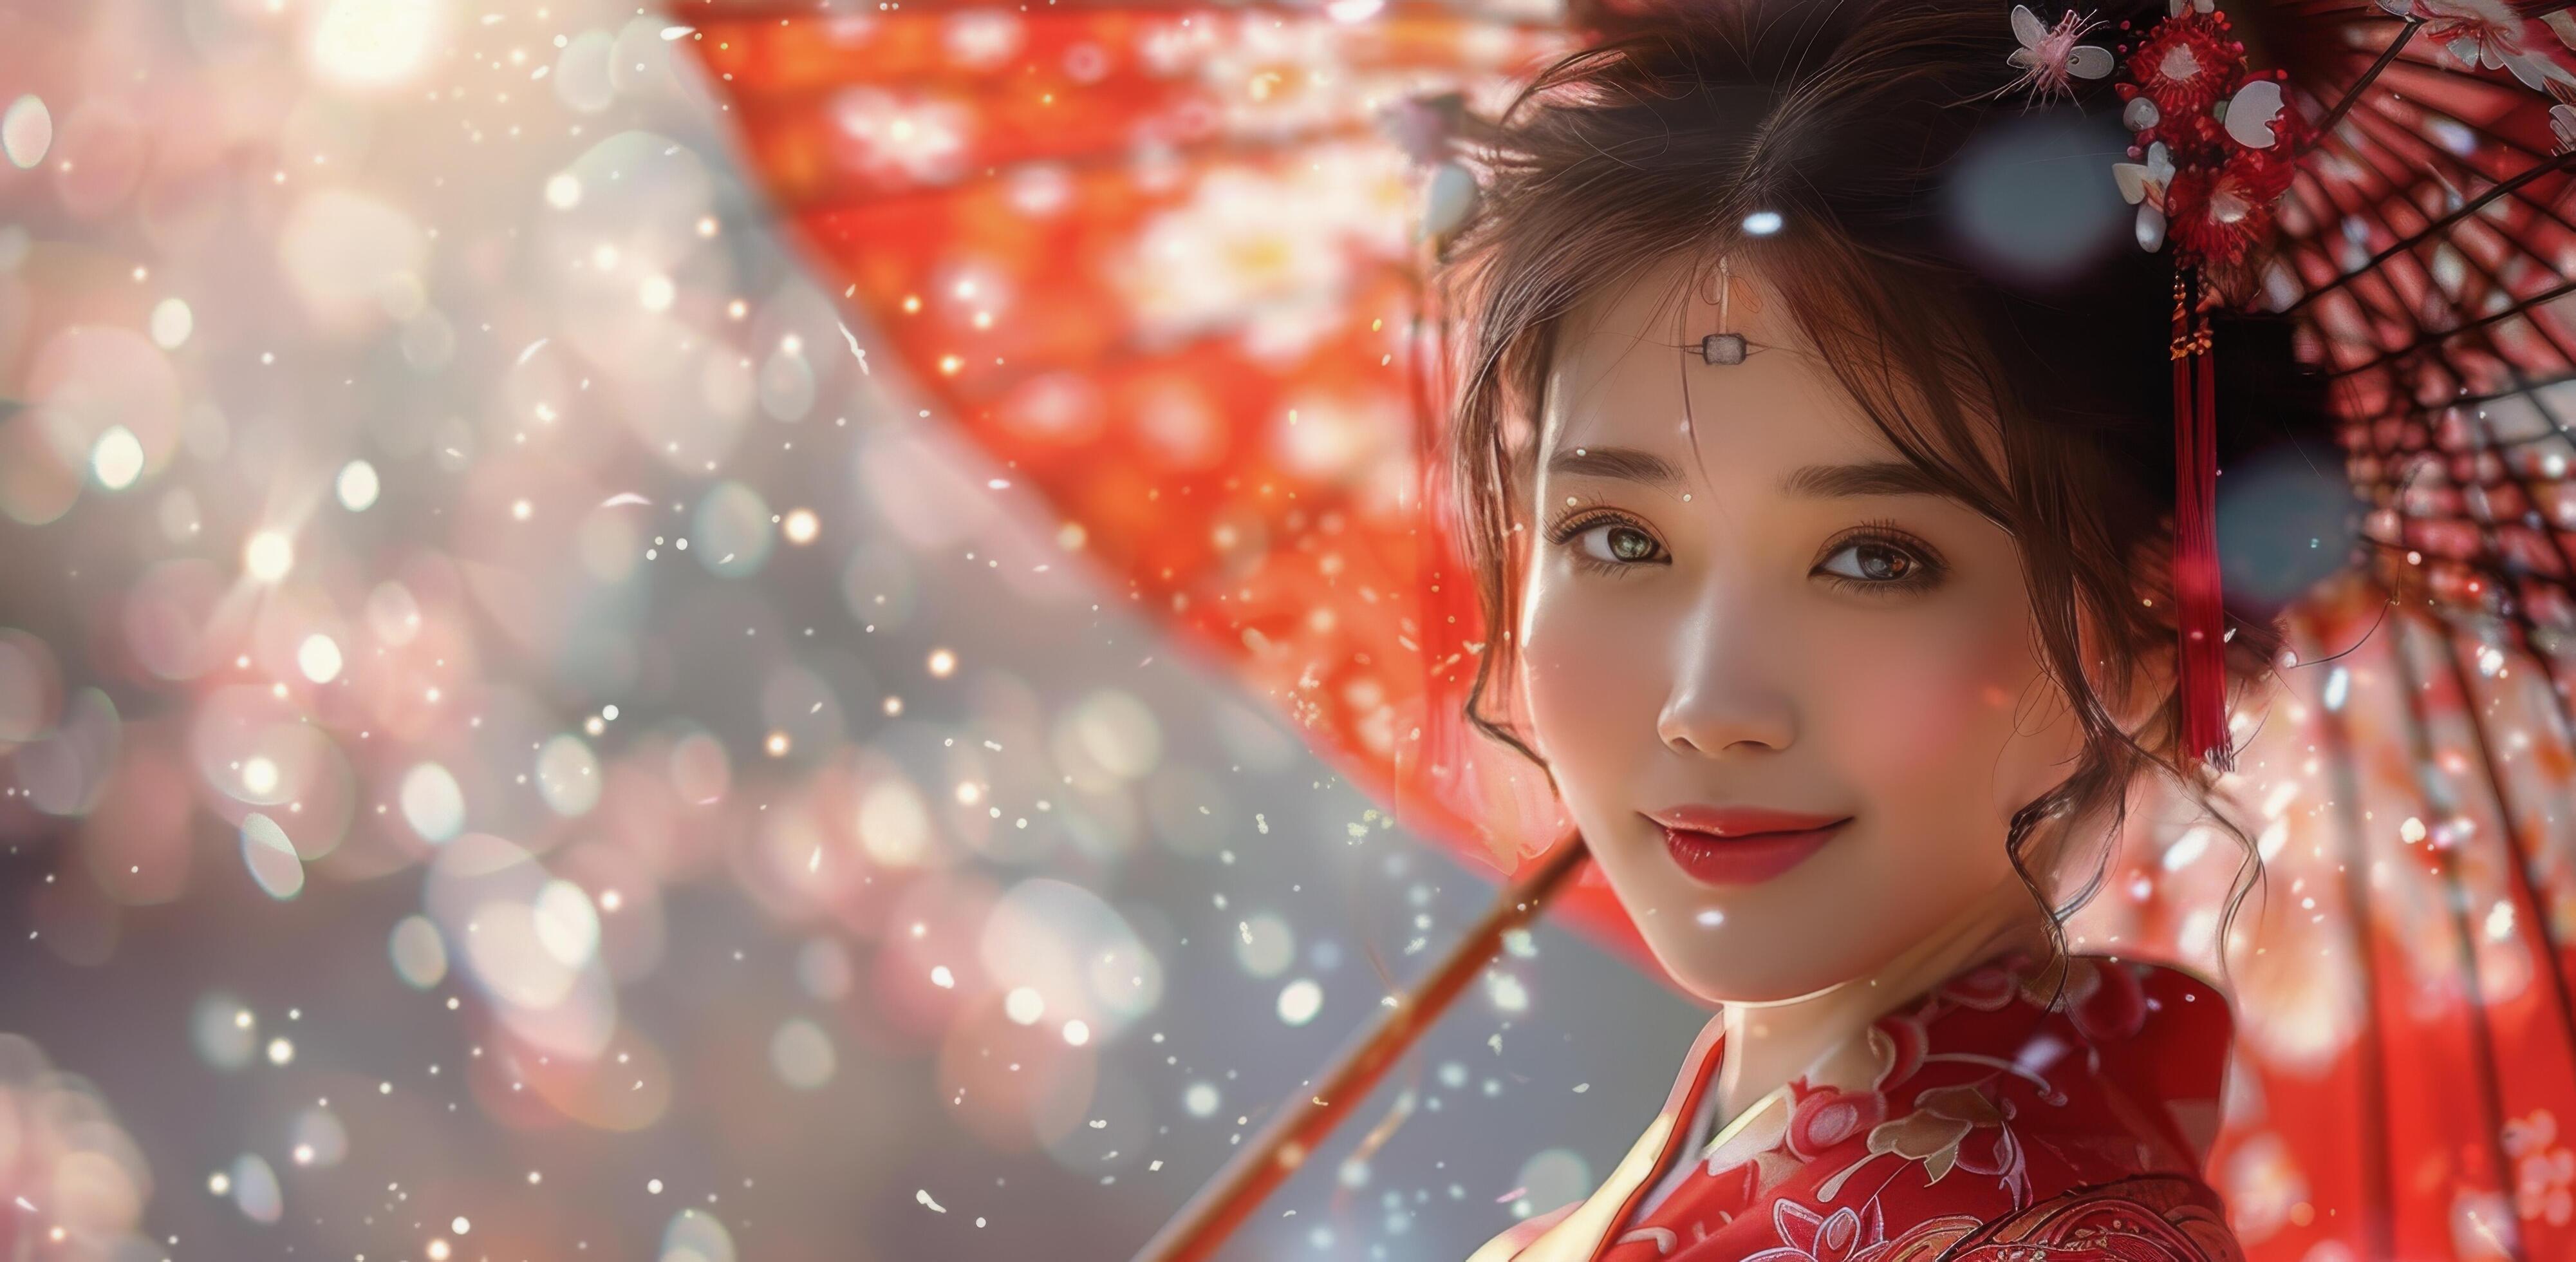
xmin=688 ymin=3 xmax=1648 ymax=963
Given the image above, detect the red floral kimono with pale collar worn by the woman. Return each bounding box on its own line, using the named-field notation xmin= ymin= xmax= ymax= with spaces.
xmin=1471 ymin=953 xmax=2244 ymax=1262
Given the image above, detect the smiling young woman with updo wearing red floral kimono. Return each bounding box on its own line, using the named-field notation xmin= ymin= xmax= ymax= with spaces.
xmin=1440 ymin=0 xmax=2326 ymax=1262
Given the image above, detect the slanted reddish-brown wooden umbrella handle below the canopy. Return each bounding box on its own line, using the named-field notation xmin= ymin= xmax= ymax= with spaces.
xmin=1136 ymin=834 xmax=1584 ymax=1262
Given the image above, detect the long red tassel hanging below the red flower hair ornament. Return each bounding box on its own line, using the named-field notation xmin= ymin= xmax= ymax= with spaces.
xmin=2172 ymin=270 xmax=2236 ymax=773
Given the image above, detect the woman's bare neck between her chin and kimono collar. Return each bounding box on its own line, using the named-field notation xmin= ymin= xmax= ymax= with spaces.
xmin=1715 ymin=881 xmax=2053 ymax=1118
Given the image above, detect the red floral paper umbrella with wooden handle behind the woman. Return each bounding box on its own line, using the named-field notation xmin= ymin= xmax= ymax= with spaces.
xmin=680 ymin=0 xmax=2576 ymax=1262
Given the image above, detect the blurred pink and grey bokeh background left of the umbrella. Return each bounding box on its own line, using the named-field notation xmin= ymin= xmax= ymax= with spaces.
xmin=0 ymin=0 xmax=1705 ymax=1262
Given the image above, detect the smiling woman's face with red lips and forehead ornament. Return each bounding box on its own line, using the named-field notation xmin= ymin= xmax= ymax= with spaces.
xmin=1520 ymin=260 xmax=2079 ymax=1002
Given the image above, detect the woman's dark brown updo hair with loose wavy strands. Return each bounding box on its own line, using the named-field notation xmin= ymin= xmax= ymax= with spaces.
xmin=1432 ymin=0 xmax=2331 ymax=968
